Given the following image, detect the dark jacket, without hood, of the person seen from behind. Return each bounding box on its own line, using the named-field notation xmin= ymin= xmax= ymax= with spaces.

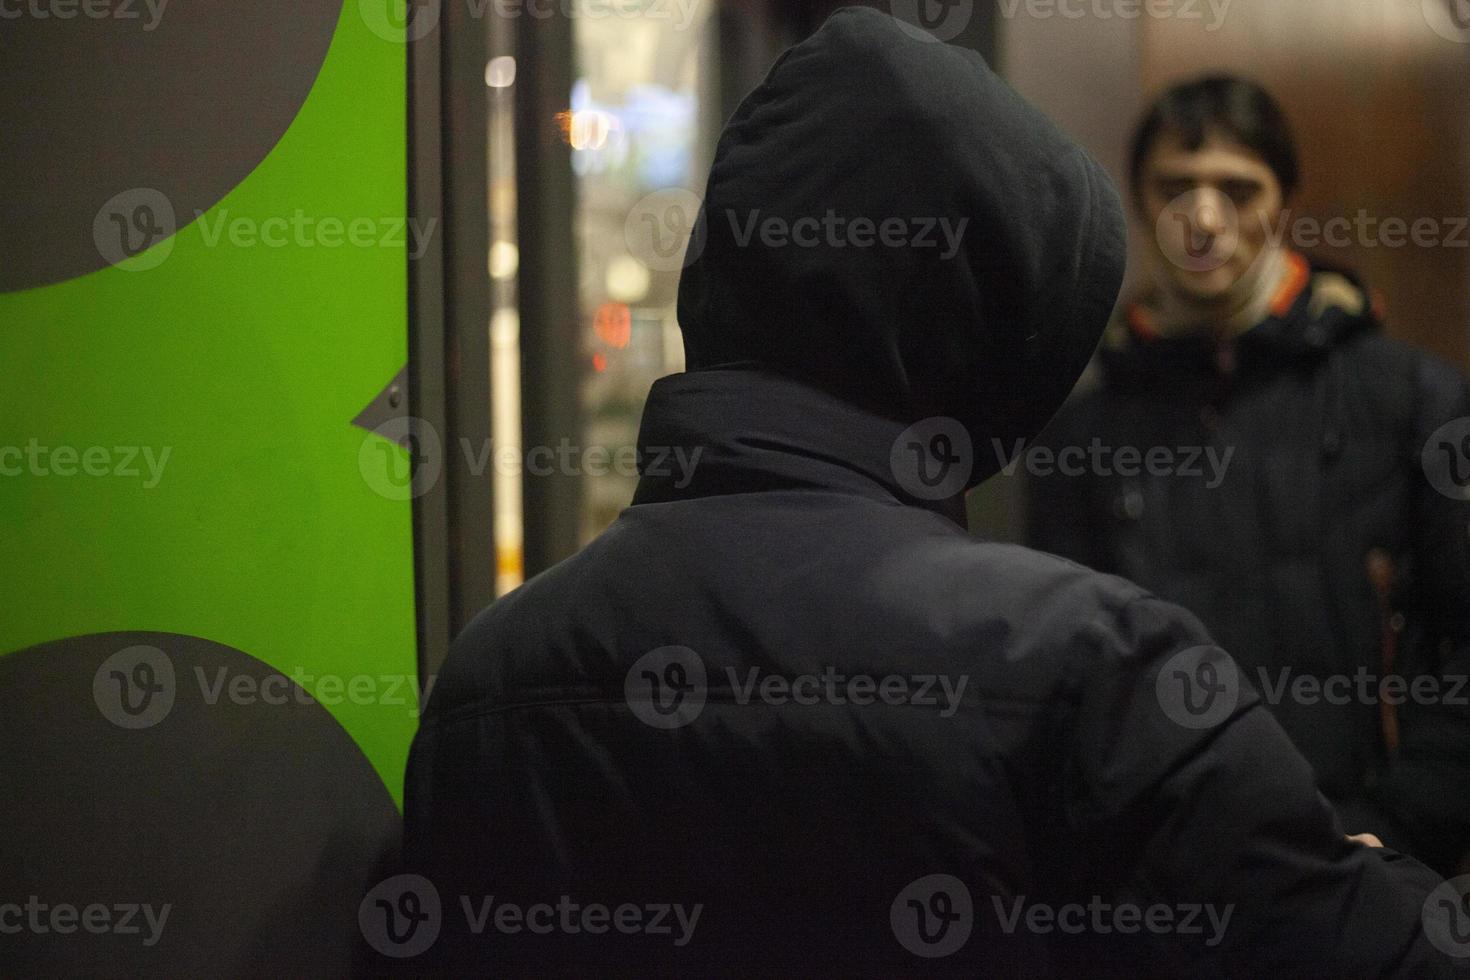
xmin=406 ymin=370 xmax=1452 ymax=979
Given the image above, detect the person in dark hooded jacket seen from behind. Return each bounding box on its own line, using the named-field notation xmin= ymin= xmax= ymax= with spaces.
xmin=406 ymin=9 xmax=1464 ymax=977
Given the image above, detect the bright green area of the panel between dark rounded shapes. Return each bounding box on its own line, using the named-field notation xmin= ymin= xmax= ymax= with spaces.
xmin=0 ymin=1 xmax=416 ymax=801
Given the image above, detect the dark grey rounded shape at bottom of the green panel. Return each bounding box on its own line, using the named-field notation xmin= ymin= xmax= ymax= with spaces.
xmin=0 ymin=632 xmax=400 ymax=977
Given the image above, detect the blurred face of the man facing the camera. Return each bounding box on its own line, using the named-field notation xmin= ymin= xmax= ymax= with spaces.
xmin=1139 ymin=134 xmax=1283 ymax=303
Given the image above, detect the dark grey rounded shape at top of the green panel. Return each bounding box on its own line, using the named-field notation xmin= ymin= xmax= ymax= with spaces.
xmin=0 ymin=0 xmax=343 ymax=292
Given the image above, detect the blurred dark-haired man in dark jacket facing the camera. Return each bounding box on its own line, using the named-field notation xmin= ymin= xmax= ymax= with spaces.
xmin=1028 ymin=76 xmax=1470 ymax=873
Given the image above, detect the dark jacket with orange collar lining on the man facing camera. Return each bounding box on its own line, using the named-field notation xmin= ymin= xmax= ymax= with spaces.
xmin=1028 ymin=254 xmax=1470 ymax=870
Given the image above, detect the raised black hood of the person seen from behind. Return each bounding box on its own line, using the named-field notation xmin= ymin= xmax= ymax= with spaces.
xmin=679 ymin=7 xmax=1126 ymax=485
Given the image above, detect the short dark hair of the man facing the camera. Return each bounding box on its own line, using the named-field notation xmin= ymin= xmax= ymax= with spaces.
xmin=1129 ymin=75 xmax=1301 ymax=204
